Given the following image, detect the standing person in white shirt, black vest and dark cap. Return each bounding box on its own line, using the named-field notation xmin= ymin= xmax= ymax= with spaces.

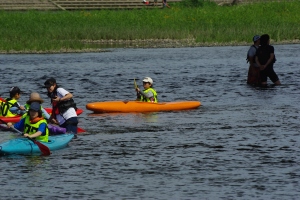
xmin=44 ymin=78 xmax=78 ymax=138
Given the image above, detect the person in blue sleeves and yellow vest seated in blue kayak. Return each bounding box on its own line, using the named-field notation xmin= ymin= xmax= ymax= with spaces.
xmin=7 ymin=102 xmax=49 ymax=142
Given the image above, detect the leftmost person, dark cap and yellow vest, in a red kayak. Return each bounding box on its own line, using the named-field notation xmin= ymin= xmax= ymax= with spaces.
xmin=0 ymin=87 xmax=25 ymax=117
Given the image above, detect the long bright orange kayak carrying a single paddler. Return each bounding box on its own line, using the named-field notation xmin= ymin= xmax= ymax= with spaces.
xmin=86 ymin=101 xmax=201 ymax=113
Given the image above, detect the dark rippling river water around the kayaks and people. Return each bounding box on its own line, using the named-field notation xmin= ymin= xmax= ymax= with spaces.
xmin=0 ymin=44 xmax=300 ymax=200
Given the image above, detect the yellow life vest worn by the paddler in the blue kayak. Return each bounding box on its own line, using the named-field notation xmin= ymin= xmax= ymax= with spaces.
xmin=24 ymin=115 xmax=49 ymax=142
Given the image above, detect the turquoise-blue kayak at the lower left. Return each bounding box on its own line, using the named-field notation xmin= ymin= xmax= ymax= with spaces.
xmin=0 ymin=134 xmax=74 ymax=154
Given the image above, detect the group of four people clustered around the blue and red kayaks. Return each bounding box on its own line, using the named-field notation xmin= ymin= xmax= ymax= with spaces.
xmin=0 ymin=78 xmax=78 ymax=142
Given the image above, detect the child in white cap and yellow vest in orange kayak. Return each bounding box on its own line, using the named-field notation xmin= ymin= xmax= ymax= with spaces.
xmin=136 ymin=77 xmax=158 ymax=103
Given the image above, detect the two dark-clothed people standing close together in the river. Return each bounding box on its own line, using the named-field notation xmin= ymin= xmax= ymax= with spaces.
xmin=247 ymin=34 xmax=281 ymax=86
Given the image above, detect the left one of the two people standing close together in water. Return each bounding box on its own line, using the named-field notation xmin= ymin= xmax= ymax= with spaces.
xmin=246 ymin=35 xmax=260 ymax=85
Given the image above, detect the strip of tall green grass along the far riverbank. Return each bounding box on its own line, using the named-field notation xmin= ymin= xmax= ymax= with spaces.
xmin=0 ymin=1 xmax=300 ymax=53
